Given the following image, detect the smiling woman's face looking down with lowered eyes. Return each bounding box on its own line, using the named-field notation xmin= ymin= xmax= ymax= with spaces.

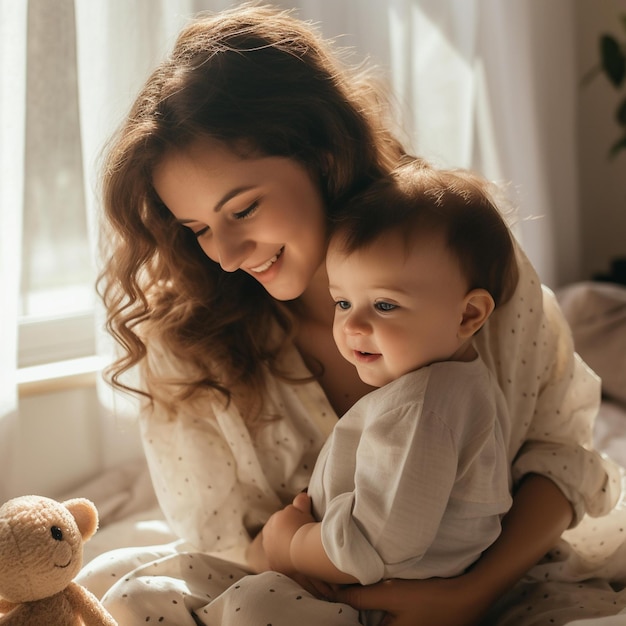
xmin=153 ymin=138 xmax=326 ymax=300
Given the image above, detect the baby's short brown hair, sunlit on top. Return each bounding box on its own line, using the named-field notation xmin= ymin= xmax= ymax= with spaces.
xmin=331 ymin=158 xmax=519 ymax=307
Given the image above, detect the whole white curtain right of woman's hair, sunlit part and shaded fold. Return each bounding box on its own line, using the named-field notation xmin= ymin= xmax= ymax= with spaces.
xmin=382 ymin=0 xmax=580 ymax=286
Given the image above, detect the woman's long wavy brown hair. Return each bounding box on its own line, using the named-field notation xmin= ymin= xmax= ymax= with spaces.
xmin=98 ymin=4 xmax=401 ymax=419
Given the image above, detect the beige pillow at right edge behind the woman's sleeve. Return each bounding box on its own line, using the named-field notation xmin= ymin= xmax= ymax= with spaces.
xmin=556 ymin=282 xmax=626 ymax=406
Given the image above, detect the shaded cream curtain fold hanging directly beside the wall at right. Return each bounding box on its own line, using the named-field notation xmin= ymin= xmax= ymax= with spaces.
xmin=479 ymin=0 xmax=581 ymax=287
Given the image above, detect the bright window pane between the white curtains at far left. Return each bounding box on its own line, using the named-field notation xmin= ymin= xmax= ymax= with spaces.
xmin=18 ymin=0 xmax=95 ymax=367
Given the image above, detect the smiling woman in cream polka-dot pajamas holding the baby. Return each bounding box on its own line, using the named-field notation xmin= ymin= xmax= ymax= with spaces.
xmin=81 ymin=6 xmax=626 ymax=626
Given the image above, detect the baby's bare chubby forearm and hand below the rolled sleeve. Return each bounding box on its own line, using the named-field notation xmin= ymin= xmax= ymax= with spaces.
xmin=263 ymin=493 xmax=358 ymax=584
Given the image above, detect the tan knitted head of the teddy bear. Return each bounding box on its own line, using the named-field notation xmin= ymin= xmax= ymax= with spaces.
xmin=0 ymin=496 xmax=98 ymax=604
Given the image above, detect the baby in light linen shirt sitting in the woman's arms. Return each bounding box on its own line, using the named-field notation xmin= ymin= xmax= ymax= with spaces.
xmin=263 ymin=160 xmax=518 ymax=624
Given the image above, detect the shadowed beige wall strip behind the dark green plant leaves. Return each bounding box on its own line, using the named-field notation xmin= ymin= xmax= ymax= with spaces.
xmin=575 ymin=0 xmax=626 ymax=278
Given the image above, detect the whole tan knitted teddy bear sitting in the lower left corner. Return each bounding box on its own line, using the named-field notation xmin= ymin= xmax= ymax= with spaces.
xmin=0 ymin=496 xmax=117 ymax=626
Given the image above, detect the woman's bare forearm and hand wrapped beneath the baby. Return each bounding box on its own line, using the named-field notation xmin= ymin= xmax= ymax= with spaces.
xmin=336 ymin=474 xmax=573 ymax=626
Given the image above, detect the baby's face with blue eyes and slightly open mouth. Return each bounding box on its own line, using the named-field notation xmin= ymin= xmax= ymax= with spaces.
xmin=326 ymin=233 xmax=468 ymax=387
